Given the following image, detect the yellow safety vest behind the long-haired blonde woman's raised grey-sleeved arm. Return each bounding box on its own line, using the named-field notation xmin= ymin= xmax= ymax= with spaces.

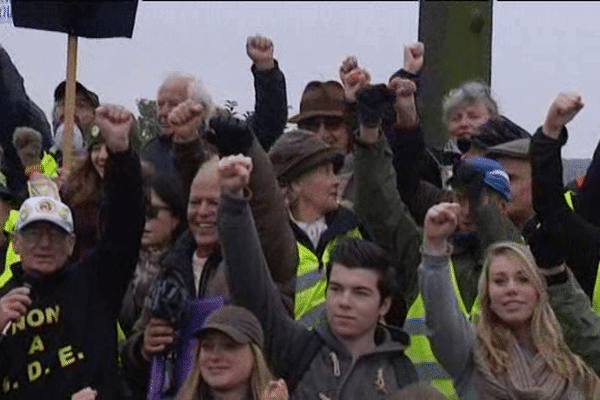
xmin=404 ymin=260 xmax=481 ymax=400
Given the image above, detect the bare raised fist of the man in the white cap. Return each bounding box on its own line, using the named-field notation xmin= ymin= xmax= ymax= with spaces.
xmin=96 ymin=104 xmax=133 ymax=153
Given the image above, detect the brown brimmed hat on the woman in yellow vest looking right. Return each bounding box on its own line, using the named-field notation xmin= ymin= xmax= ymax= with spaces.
xmin=269 ymin=129 xmax=344 ymax=184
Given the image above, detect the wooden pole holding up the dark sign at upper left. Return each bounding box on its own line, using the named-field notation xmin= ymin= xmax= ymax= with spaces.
xmin=62 ymin=34 xmax=77 ymax=169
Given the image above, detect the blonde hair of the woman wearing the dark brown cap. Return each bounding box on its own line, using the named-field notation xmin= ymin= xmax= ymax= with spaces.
xmin=176 ymin=343 xmax=274 ymax=400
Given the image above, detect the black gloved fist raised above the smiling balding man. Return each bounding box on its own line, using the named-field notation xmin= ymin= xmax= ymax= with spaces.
xmin=206 ymin=115 xmax=254 ymax=157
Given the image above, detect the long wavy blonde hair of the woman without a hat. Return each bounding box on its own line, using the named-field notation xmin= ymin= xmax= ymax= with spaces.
xmin=475 ymin=242 xmax=600 ymax=398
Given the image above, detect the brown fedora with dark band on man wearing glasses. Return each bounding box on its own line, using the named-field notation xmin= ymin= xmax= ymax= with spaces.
xmin=289 ymin=81 xmax=346 ymax=123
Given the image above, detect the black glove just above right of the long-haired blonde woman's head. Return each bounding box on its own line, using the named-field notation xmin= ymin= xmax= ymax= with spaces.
xmin=527 ymin=221 xmax=566 ymax=268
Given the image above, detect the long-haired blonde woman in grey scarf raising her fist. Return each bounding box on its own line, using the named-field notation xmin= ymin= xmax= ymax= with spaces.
xmin=419 ymin=203 xmax=600 ymax=400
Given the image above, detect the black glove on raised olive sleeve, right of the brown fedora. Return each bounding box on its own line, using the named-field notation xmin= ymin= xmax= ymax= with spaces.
xmin=356 ymin=84 xmax=395 ymax=128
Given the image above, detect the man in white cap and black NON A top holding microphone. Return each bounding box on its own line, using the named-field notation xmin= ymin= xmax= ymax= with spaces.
xmin=0 ymin=105 xmax=144 ymax=399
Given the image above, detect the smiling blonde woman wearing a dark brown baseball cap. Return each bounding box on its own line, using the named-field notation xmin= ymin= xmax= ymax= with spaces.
xmin=177 ymin=305 xmax=287 ymax=400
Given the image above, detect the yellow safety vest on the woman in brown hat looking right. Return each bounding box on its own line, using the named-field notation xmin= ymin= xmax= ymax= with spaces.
xmin=294 ymin=228 xmax=362 ymax=327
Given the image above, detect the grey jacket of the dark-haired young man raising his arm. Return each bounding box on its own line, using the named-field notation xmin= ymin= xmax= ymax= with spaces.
xmin=219 ymin=196 xmax=416 ymax=399
